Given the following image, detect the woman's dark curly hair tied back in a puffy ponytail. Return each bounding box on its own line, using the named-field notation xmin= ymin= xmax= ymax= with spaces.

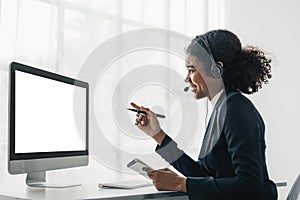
xmin=187 ymin=30 xmax=272 ymax=94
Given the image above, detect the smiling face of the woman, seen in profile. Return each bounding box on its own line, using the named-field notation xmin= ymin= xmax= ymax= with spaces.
xmin=185 ymin=54 xmax=211 ymax=99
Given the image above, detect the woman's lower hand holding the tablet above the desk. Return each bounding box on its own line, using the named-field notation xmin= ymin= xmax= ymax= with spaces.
xmin=147 ymin=168 xmax=186 ymax=192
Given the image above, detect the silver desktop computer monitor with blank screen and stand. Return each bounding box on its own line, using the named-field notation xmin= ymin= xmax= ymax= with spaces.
xmin=8 ymin=62 xmax=89 ymax=187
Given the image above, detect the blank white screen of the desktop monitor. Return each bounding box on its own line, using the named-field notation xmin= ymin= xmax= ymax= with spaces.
xmin=15 ymin=71 xmax=86 ymax=153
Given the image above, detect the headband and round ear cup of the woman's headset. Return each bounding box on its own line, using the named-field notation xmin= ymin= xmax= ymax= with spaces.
xmin=197 ymin=34 xmax=224 ymax=78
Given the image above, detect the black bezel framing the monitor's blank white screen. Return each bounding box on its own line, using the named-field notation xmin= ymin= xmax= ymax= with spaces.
xmin=9 ymin=62 xmax=89 ymax=161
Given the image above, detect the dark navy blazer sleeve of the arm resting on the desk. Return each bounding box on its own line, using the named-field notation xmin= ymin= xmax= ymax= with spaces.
xmin=186 ymin=96 xmax=264 ymax=200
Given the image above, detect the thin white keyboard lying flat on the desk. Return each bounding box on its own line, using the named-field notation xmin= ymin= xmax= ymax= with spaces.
xmin=98 ymin=179 xmax=153 ymax=189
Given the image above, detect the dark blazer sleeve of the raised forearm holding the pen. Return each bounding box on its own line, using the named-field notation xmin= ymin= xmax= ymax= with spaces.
xmin=155 ymin=135 xmax=205 ymax=177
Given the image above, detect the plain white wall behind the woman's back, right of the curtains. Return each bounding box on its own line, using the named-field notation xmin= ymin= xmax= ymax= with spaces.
xmin=225 ymin=0 xmax=300 ymax=199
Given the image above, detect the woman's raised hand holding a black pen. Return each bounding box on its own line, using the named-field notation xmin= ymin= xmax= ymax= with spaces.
xmin=130 ymin=102 xmax=165 ymax=144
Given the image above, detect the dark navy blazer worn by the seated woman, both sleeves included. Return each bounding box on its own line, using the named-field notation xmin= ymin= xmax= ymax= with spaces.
xmin=156 ymin=92 xmax=277 ymax=200
